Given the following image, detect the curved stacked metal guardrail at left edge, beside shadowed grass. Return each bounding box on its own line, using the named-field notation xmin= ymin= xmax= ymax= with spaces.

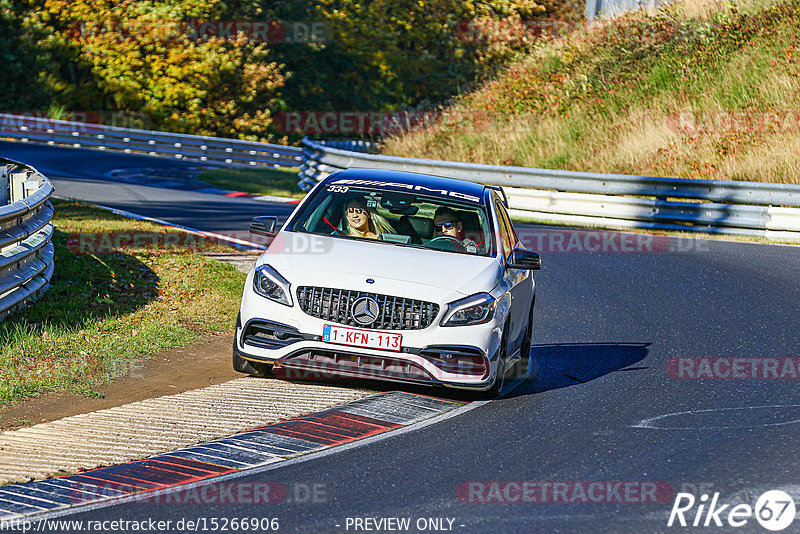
xmin=0 ymin=159 xmax=55 ymax=319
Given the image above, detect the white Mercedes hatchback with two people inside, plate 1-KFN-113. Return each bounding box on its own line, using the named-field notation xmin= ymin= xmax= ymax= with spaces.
xmin=233 ymin=169 xmax=541 ymax=393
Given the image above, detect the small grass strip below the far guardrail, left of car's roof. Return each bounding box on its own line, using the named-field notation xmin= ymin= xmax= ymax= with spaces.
xmin=200 ymin=167 xmax=305 ymax=198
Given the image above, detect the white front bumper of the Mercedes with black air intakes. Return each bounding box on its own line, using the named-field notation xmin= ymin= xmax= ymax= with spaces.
xmin=235 ymin=262 xmax=505 ymax=390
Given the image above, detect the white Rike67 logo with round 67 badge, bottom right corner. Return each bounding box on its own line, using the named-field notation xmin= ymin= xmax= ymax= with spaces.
xmin=667 ymin=490 xmax=795 ymax=531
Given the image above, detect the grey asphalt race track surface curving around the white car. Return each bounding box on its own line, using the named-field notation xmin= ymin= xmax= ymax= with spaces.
xmin=0 ymin=140 xmax=800 ymax=533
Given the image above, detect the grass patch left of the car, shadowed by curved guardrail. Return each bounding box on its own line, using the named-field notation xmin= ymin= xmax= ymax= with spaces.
xmin=0 ymin=200 xmax=244 ymax=404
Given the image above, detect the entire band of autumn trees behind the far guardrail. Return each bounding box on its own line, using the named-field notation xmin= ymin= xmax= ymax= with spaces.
xmin=0 ymin=0 xmax=566 ymax=140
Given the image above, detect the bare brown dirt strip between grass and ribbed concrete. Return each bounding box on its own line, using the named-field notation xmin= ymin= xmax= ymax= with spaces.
xmin=0 ymin=334 xmax=244 ymax=430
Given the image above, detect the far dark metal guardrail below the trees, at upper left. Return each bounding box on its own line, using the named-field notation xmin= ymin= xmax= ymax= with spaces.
xmin=0 ymin=113 xmax=301 ymax=166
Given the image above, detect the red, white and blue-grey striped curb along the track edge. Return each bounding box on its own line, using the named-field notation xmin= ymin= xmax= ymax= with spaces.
xmin=0 ymin=391 xmax=460 ymax=529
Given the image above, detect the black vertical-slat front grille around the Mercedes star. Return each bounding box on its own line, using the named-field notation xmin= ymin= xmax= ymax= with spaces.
xmin=297 ymin=286 xmax=439 ymax=330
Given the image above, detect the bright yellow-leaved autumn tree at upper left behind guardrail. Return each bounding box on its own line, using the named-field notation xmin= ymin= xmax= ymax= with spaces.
xmin=16 ymin=0 xmax=284 ymax=139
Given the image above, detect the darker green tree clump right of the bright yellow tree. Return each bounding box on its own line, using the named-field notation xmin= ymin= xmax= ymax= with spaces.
xmin=272 ymin=0 xmax=547 ymax=111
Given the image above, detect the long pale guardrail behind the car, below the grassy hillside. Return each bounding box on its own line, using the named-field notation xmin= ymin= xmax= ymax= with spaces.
xmin=298 ymin=138 xmax=800 ymax=241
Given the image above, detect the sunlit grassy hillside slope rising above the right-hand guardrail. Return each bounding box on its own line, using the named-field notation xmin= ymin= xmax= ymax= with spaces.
xmin=383 ymin=0 xmax=800 ymax=183
